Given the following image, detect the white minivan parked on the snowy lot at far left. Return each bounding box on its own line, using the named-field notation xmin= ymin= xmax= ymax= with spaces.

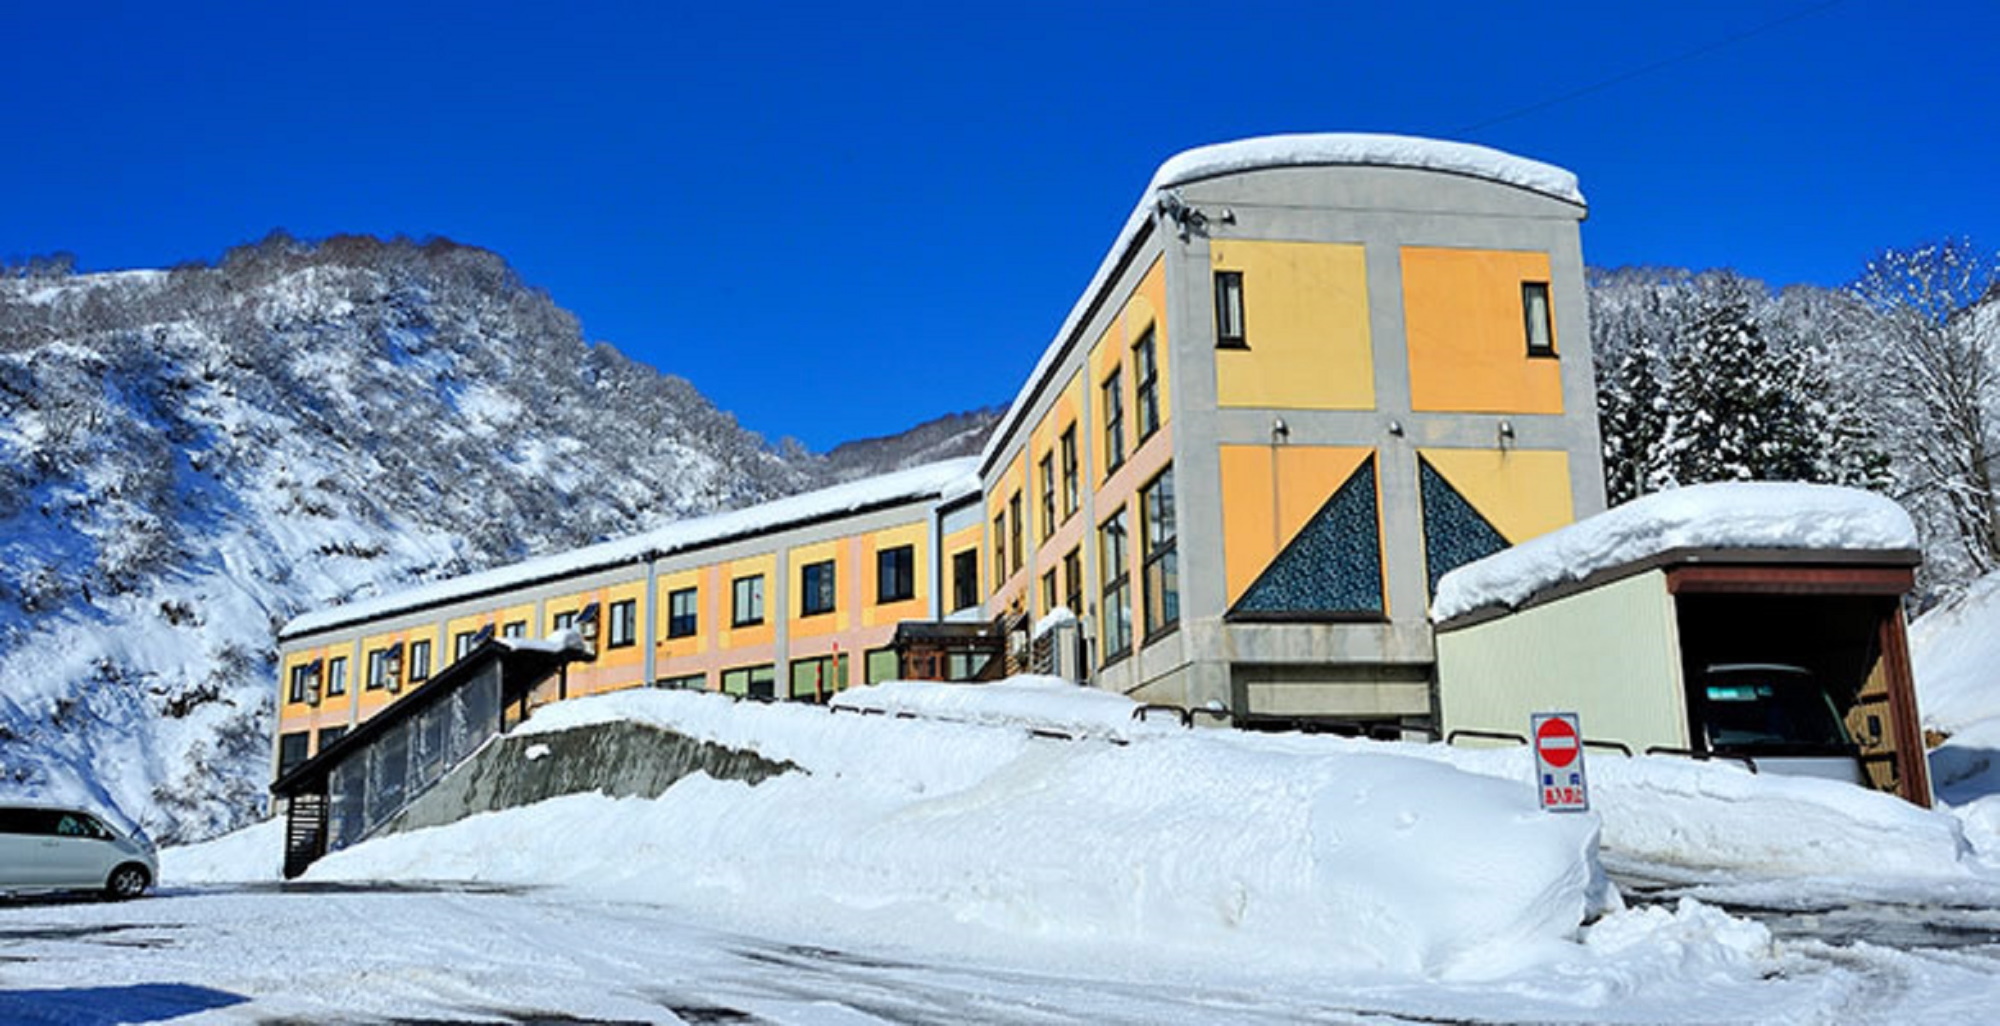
xmin=0 ymin=804 xmax=160 ymax=898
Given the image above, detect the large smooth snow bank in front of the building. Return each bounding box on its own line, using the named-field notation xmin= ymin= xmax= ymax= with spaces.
xmin=328 ymin=682 xmax=1602 ymax=974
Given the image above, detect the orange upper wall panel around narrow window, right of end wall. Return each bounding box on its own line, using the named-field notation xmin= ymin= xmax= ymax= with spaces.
xmin=1408 ymin=246 xmax=1562 ymax=414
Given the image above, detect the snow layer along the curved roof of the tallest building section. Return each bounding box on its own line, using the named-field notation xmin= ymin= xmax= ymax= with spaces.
xmin=980 ymin=132 xmax=1586 ymax=476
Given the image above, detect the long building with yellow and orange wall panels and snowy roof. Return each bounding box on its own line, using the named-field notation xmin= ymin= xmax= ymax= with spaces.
xmin=276 ymin=134 xmax=1604 ymax=766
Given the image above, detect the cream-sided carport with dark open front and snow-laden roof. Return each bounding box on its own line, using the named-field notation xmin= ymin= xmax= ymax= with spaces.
xmin=1434 ymin=484 xmax=1930 ymax=806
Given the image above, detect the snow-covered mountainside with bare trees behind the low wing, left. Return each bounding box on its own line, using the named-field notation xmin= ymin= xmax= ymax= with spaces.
xmin=0 ymin=234 xmax=984 ymax=840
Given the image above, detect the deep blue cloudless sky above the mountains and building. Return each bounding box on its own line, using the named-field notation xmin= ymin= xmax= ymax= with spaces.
xmin=0 ymin=0 xmax=2000 ymax=448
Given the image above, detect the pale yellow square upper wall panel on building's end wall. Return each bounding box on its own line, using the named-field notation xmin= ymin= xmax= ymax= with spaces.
xmin=1208 ymin=238 xmax=1376 ymax=410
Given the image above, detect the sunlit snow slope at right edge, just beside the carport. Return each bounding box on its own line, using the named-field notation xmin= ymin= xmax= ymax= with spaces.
xmin=1910 ymin=572 xmax=2000 ymax=734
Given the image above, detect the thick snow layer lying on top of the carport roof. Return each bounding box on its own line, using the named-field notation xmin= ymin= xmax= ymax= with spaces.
xmin=1430 ymin=482 xmax=1916 ymax=624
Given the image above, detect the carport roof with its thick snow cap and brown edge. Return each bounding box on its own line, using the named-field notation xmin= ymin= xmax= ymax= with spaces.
xmin=1430 ymin=482 xmax=1922 ymax=630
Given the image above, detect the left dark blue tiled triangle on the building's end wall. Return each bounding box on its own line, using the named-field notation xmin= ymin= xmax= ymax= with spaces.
xmin=1230 ymin=456 xmax=1382 ymax=616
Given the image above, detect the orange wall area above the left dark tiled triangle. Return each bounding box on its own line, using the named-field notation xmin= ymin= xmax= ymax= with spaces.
xmin=1220 ymin=446 xmax=1388 ymax=612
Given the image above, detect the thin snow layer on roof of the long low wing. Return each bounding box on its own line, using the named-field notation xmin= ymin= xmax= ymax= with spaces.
xmin=278 ymin=456 xmax=974 ymax=638
